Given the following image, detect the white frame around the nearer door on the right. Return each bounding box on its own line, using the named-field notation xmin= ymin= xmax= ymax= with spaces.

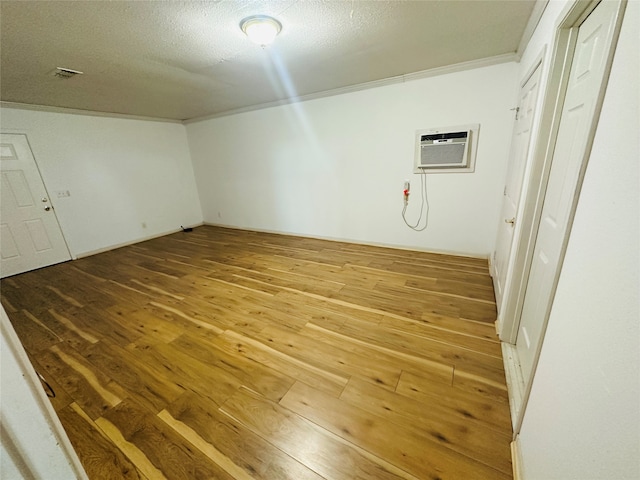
xmin=499 ymin=0 xmax=627 ymax=439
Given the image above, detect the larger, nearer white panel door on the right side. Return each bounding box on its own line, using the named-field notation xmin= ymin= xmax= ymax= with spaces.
xmin=516 ymin=2 xmax=619 ymax=382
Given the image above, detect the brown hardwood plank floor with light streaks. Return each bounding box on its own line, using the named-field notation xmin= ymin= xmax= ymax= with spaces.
xmin=1 ymin=227 xmax=512 ymax=480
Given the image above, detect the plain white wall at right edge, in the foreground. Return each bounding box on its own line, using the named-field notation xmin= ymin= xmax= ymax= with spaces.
xmin=520 ymin=1 xmax=640 ymax=480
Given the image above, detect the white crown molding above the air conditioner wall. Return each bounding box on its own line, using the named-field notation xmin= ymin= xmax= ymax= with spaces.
xmin=182 ymin=53 xmax=518 ymax=125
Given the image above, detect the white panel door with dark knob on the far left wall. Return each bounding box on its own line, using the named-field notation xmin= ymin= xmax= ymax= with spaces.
xmin=0 ymin=134 xmax=71 ymax=278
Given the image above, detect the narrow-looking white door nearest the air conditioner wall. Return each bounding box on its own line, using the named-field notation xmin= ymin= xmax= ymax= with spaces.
xmin=493 ymin=64 xmax=542 ymax=314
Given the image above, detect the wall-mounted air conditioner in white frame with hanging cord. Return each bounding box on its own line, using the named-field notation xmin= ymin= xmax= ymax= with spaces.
xmin=413 ymin=124 xmax=480 ymax=173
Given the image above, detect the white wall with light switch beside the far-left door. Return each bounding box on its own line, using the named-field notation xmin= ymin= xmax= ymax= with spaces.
xmin=0 ymin=108 xmax=202 ymax=256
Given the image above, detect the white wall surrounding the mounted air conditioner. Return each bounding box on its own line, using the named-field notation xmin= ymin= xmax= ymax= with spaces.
xmin=187 ymin=63 xmax=518 ymax=256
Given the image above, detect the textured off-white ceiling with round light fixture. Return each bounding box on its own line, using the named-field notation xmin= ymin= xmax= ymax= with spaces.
xmin=0 ymin=0 xmax=535 ymax=120
